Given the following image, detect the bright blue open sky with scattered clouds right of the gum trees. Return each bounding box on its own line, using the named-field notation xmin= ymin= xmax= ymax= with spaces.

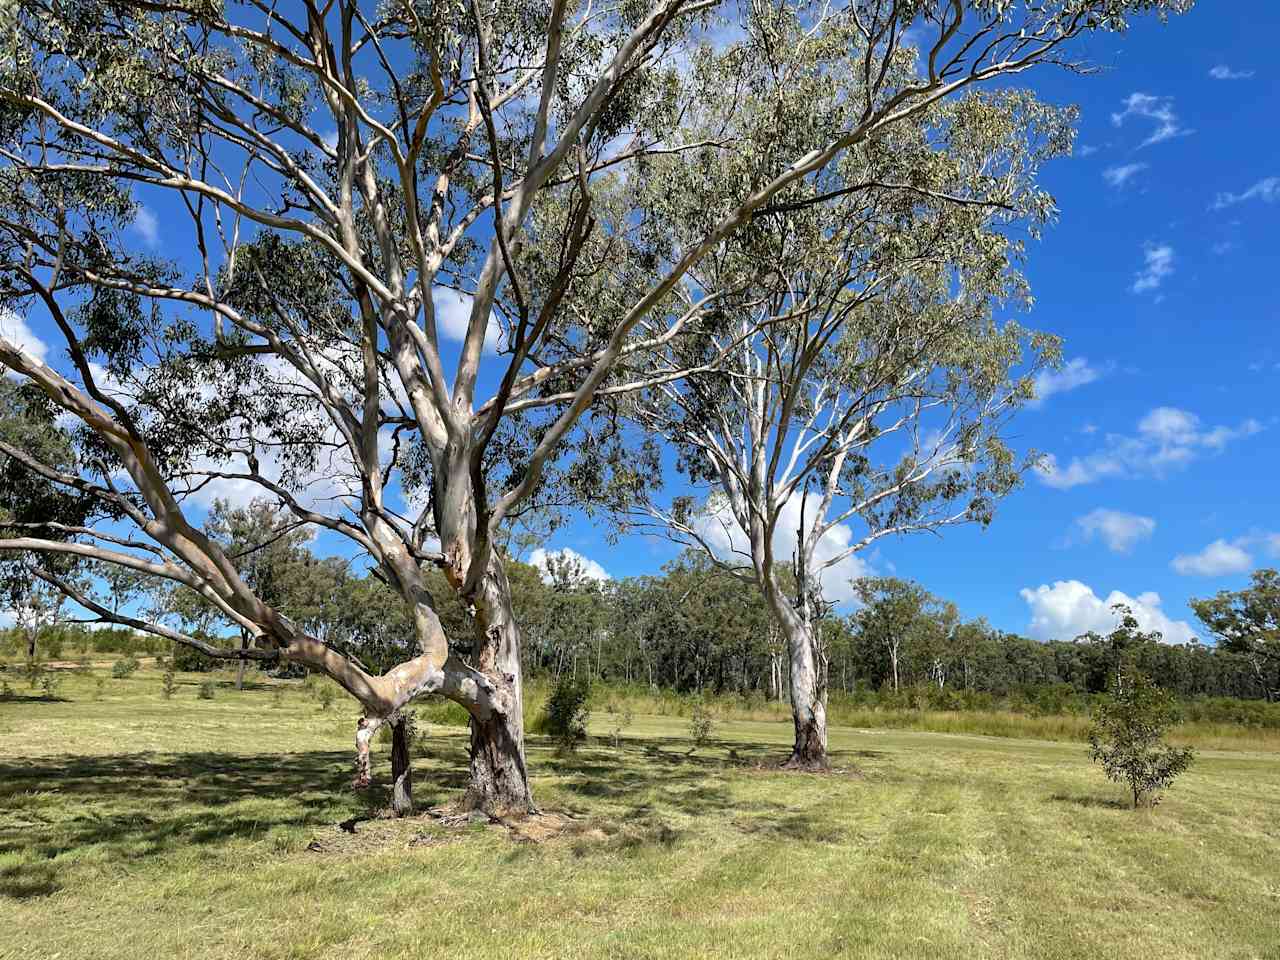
xmin=5 ymin=0 xmax=1280 ymax=640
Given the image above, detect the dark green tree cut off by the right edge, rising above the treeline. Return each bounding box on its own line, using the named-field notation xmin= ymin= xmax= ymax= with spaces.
xmin=1190 ymin=570 xmax=1280 ymax=701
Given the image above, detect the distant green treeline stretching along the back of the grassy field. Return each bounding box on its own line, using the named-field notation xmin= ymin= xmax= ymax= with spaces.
xmin=12 ymin=544 xmax=1266 ymax=710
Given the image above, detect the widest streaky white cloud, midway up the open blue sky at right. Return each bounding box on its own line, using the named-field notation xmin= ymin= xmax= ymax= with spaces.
xmin=1038 ymin=407 xmax=1262 ymax=490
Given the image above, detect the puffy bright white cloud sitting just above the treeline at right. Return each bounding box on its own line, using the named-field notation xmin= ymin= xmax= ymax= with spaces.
xmin=1019 ymin=580 xmax=1196 ymax=644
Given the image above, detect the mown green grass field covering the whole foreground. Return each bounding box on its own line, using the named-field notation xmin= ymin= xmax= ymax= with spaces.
xmin=0 ymin=668 xmax=1280 ymax=960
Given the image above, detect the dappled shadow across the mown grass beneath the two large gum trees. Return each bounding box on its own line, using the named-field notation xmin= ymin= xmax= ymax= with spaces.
xmin=0 ymin=736 xmax=890 ymax=900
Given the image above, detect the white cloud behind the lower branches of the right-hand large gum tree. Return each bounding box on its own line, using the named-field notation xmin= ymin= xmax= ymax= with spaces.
xmin=694 ymin=492 xmax=873 ymax=603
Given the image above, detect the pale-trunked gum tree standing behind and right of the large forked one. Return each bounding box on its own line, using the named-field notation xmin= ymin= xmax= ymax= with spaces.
xmin=632 ymin=37 xmax=1074 ymax=768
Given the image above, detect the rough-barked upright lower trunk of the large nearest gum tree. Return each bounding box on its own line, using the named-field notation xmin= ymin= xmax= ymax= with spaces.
xmin=462 ymin=558 xmax=535 ymax=817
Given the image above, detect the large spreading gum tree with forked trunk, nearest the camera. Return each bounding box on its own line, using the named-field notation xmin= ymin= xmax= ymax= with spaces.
xmin=0 ymin=0 xmax=1189 ymax=810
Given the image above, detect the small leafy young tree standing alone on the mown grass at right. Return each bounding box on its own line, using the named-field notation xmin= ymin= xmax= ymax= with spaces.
xmin=1089 ymin=669 xmax=1194 ymax=809
